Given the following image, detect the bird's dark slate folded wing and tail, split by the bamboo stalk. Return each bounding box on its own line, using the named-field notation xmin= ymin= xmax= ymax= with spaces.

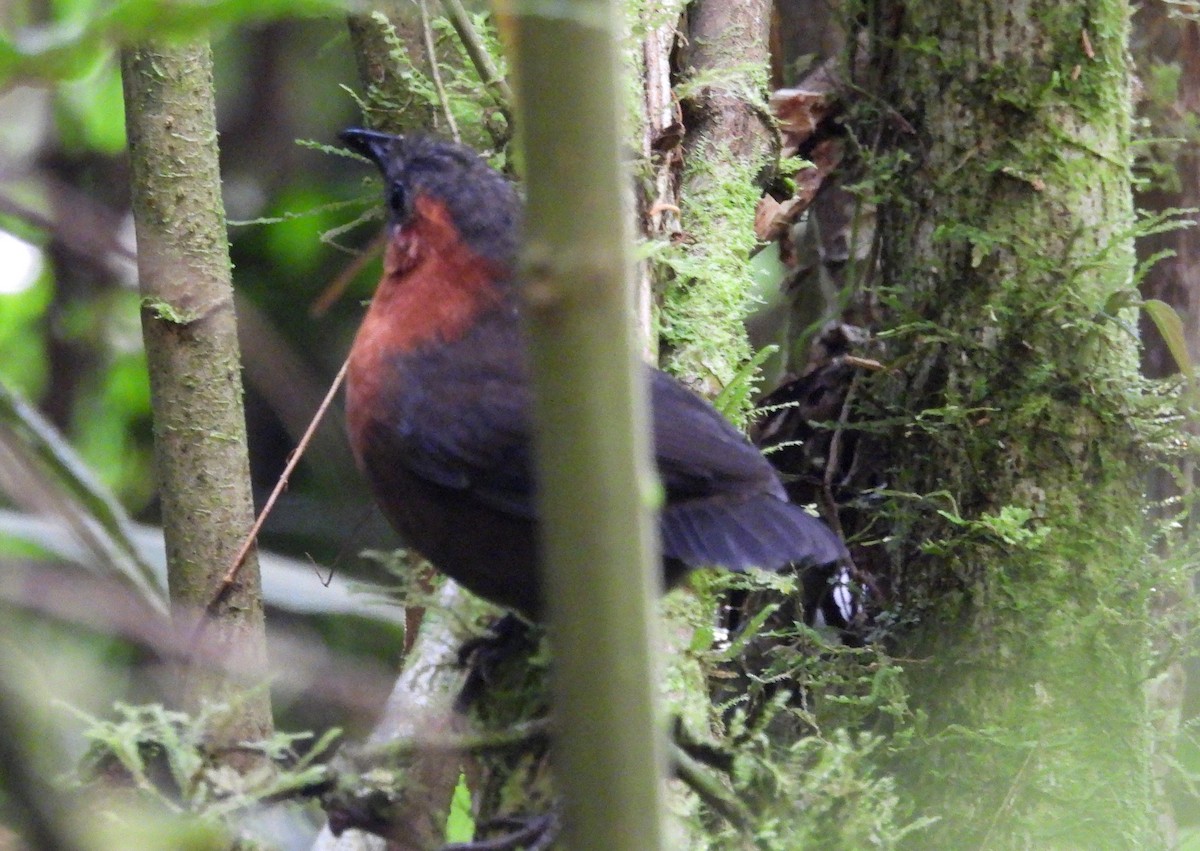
xmin=384 ymin=336 xmax=845 ymax=570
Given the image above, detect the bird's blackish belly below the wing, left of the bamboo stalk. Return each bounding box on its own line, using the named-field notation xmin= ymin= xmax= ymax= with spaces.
xmin=364 ymin=457 xmax=541 ymax=618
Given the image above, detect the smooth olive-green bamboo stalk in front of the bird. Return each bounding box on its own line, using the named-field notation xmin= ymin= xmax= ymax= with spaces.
xmin=512 ymin=0 xmax=665 ymax=851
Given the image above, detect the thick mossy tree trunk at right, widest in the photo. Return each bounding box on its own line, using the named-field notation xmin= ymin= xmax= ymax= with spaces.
xmin=857 ymin=0 xmax=1159 ymax=849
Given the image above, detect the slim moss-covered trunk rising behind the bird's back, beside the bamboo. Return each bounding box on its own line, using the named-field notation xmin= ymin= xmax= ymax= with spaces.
xmin=661 ymin=0 xmax=778 ymax=405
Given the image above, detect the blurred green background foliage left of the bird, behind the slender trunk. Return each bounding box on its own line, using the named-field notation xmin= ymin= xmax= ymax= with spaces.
xmin=0 ymin=0 xmax=415 ymax=773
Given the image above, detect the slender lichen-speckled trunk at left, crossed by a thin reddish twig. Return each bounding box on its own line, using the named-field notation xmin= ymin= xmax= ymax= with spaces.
xmin=121 ymin=44 xmax=271 ymax=748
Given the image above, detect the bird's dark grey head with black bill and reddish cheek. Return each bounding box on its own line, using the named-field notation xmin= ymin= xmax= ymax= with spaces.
xmin=338 ymin=128 xmax=521 ymax=268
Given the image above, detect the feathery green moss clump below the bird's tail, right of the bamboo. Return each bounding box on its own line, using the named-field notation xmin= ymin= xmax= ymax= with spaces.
xmin=691 ymin=564 xmax=928 ymax=851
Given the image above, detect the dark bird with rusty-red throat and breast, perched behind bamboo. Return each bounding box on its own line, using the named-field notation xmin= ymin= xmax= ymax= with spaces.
xmin=340 ymin=128 xmax=847 ymax=622
